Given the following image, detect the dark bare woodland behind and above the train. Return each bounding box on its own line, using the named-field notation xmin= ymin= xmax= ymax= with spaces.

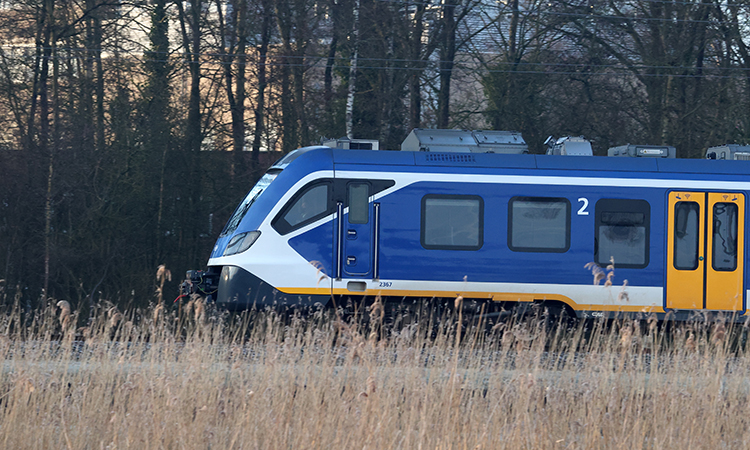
xmin=0 ymin=0 xmax=750 ymax=311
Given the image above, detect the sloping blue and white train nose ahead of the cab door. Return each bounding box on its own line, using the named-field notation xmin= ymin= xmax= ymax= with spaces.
xmin=182 ymin=147 xmax=333 ymax=310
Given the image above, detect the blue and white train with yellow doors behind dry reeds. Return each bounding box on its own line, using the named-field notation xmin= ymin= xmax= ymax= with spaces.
xmin=187 ymin=142 xmax=750 ymax=320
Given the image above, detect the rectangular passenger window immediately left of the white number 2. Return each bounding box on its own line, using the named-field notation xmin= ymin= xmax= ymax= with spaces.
xmin=508 ymin=197 xmax=570 ymax=253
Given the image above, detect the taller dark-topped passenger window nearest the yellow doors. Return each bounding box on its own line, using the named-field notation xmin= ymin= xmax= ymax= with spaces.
xmin=594 ymin=199 xmax=651 ymax=269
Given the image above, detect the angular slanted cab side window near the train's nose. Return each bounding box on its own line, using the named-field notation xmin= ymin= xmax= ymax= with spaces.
xmin=272 ymin=183 xmax=332 ymax=234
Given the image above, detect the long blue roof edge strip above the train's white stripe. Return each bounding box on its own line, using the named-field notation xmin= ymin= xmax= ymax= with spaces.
xmin=329 ymin=149 xmax=750 ymax=175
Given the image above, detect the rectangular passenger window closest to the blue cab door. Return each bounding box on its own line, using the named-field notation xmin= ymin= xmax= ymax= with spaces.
xmin=421 ymin=195 xmax=484 ymax=250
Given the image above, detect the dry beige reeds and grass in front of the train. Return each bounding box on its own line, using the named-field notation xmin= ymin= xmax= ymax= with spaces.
xmin=0 ymin=302 xmax=750 ymax=449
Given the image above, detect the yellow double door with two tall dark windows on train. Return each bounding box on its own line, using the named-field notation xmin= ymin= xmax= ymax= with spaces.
xmin=666 ymin=191 xmax=745 ymax=311
